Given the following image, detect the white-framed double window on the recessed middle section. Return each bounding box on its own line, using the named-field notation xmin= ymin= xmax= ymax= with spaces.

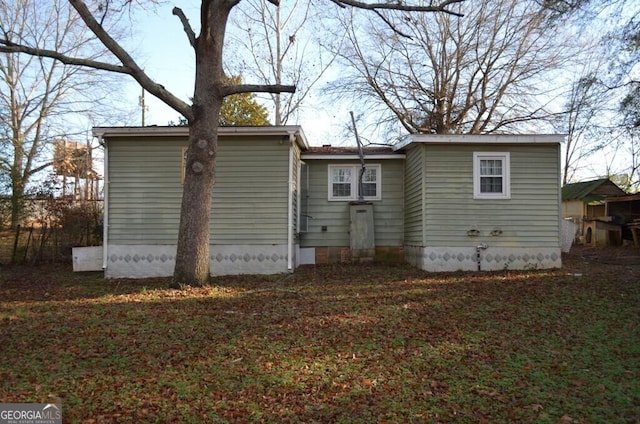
xmin=329 ymin=165 xmax=382 ymax=200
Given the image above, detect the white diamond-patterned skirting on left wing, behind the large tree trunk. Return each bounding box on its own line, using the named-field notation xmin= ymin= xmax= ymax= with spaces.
xmin=105 ymin=244 xmax=288 ymax=278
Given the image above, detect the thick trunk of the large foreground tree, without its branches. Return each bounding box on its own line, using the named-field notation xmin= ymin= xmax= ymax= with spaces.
xmin=172 ymin=0 xmax=231 ymax=287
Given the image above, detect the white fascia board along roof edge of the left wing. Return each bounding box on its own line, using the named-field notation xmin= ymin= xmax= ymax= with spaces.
xmin=93 ymin=125 xmax=309 ymax=150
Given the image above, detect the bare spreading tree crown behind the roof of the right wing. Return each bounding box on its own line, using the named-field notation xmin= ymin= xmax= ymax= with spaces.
xmin=332 ymin=0 xmax=570 ymax=134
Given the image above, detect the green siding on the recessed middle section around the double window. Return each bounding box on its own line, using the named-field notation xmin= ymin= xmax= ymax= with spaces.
xmin=300 ymin=158 xmax=404 ymax=247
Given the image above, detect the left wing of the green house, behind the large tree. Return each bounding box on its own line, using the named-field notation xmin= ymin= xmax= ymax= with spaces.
xmin=93 ymin=127 xmax=308 ymax=277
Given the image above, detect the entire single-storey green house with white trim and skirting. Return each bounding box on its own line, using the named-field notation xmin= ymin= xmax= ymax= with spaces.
xmin=89 ymin=126 xmax=563 ymax=277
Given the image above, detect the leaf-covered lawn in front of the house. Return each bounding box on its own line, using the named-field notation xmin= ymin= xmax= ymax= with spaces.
xmin=0 ymin=250 xmax=640 ymax=423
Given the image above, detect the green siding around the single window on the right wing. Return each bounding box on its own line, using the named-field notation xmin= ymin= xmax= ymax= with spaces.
xmin=423 ymin=144 xmax=560 ymax=247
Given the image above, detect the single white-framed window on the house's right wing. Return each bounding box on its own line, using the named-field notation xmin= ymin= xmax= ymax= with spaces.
xmin=473 ymin=152 xmax=511 ymax=199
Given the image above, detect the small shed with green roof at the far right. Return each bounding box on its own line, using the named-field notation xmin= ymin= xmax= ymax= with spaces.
xmin=562 ymin=178 xmax=625 ymax=245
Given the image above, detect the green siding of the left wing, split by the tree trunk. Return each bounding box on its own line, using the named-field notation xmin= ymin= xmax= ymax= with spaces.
xmin=107 ymin=132 xmax=289 ymax=245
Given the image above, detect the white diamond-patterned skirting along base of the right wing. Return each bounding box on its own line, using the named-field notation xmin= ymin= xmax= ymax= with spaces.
xmin=404 ymin=246 xmax=562 ymax=272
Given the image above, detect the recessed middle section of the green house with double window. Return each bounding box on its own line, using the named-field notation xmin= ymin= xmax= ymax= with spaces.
xmin=300 ymin=146 xmax=405 ymax=264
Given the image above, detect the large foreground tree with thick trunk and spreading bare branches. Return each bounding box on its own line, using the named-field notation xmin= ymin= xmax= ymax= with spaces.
xmin=0 ymin=0 xmax=463 ymax=285
